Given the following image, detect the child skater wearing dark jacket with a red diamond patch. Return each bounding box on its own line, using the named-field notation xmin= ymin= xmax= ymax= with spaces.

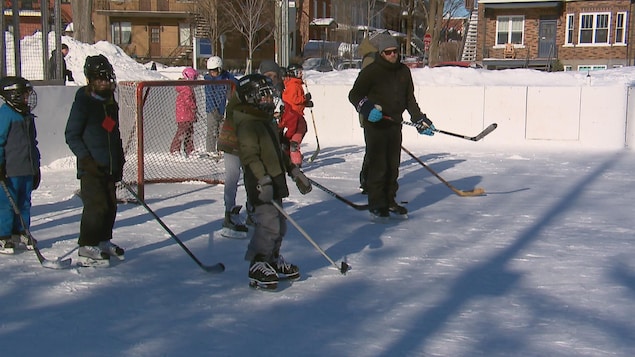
xmin=65 ymin=55 xmax=125 ymax=266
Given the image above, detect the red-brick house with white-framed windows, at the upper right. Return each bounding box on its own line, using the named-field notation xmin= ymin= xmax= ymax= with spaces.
xmin=471 ymin=0 xmax=635 ymax=70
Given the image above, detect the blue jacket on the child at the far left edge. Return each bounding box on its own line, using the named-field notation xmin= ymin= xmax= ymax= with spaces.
xmin=0 ymin=104 xmax=40 ymax=177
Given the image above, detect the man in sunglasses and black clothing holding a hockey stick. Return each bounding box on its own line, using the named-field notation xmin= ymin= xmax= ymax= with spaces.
xmin=348 ymin=34 xmax=434 ymax=221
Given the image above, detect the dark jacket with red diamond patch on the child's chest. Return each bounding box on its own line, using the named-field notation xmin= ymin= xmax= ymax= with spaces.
xmin=65 ymin=86 xmax=125 ymax=181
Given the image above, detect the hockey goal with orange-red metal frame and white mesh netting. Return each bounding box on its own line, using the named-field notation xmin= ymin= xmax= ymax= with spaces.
xmin=117 ymin=80 xmax=235 ymax=202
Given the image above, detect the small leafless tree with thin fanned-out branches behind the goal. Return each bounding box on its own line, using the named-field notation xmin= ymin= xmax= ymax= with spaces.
xmin=221 ymin=0 xmax=276 ymax=73
